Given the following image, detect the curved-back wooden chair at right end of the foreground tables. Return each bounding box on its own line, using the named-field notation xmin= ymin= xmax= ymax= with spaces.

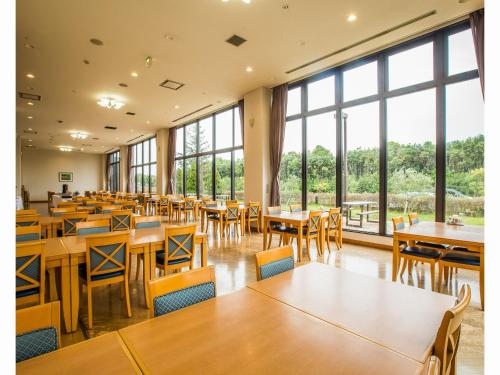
xmin=433 ymin=284 xmax=471 ymax=375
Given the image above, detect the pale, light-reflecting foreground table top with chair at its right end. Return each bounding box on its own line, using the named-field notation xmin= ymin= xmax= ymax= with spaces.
xmin=248 ymin=263 xmax=455 ymax=363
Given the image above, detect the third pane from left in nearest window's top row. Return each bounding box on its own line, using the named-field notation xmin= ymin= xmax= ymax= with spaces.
xmin=343 ymin=61 xmax=378 ymax=102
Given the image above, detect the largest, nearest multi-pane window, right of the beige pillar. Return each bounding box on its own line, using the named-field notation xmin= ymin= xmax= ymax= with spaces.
xmin=280 ymin=22 xmax=484 ymax=234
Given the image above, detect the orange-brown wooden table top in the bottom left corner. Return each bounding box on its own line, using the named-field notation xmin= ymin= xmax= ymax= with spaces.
xmin=16 ymin=332 xmax=141 ymax=375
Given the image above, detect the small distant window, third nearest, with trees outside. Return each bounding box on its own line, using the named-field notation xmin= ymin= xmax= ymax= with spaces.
xmin=130 ymin=138 xmax=157 ymax=194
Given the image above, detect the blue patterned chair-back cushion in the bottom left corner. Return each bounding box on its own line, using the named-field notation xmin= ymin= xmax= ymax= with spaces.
xmin=16 ymin=327 xmax=58 ymax=362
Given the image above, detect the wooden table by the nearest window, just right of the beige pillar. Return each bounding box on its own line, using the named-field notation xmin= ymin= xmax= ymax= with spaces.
xmin=262 ymin=211 xmax=328 ymax=262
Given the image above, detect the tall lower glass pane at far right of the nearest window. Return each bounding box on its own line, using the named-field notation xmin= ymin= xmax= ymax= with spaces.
xmin=446 ymin=79 xmax=484 ymax=225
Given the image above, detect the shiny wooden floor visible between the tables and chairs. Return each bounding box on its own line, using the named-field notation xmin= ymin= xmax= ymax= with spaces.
xmin=32 ymin=204 xmax=484 ymax=374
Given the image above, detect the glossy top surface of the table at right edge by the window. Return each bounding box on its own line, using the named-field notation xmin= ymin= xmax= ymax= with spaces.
xmin=394 ymin=221 xmax=484 ymax=245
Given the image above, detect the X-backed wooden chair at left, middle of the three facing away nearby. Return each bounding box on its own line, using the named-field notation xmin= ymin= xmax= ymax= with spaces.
xmin=79 ymin=233 xmax=132 ymax=328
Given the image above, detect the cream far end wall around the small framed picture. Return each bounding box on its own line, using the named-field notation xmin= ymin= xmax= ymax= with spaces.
xmin=21 ymin=148 xmax=103 ymax=201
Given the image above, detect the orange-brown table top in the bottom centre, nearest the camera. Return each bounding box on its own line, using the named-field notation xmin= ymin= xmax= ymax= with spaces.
xmin=119 ymin=288 xmax=423 ymax=374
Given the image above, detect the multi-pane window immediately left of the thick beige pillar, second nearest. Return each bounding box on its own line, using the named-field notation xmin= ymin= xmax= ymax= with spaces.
xmin=175 ymin=106 xmax=244 ymax=200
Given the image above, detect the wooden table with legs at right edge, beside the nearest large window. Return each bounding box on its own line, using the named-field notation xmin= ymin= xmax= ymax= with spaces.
xmin=392 ymin=221 xmax=484 ymax=309
